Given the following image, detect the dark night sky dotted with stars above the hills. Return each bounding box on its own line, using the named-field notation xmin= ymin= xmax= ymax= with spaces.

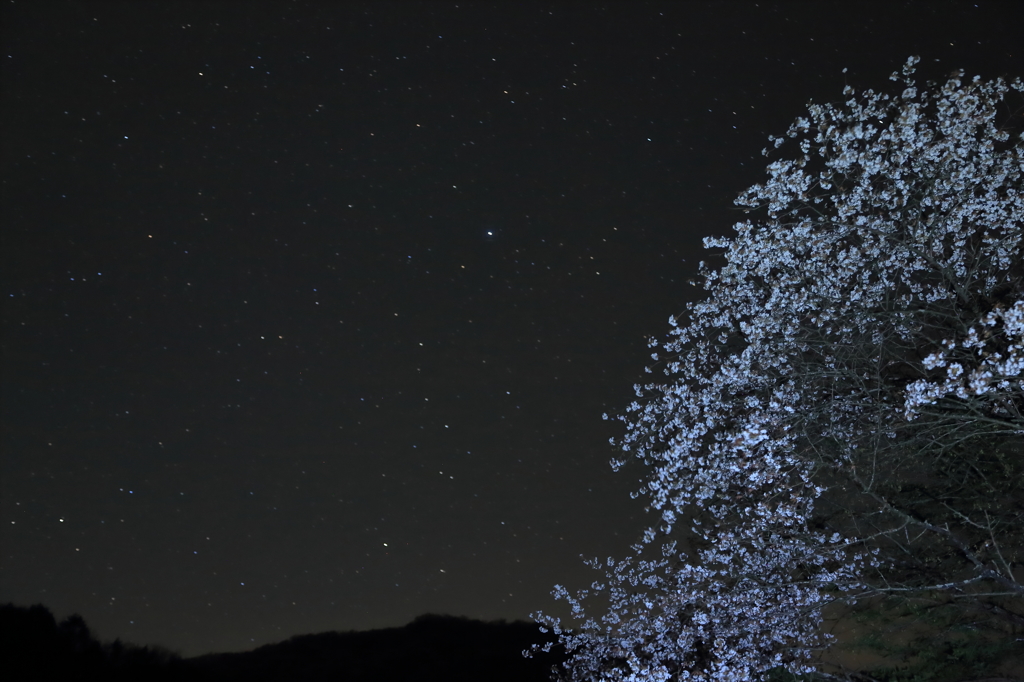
xmin=0 ymin=0 xmax=1024 ymax=654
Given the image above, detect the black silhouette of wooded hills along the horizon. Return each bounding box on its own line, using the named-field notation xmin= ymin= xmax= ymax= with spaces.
xmin=0 ymin=604 xmax=562 ymax=682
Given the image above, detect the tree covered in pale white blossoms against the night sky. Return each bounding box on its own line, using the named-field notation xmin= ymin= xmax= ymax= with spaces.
xmin=537 ymin=57 xmax=1024 ymax=681
